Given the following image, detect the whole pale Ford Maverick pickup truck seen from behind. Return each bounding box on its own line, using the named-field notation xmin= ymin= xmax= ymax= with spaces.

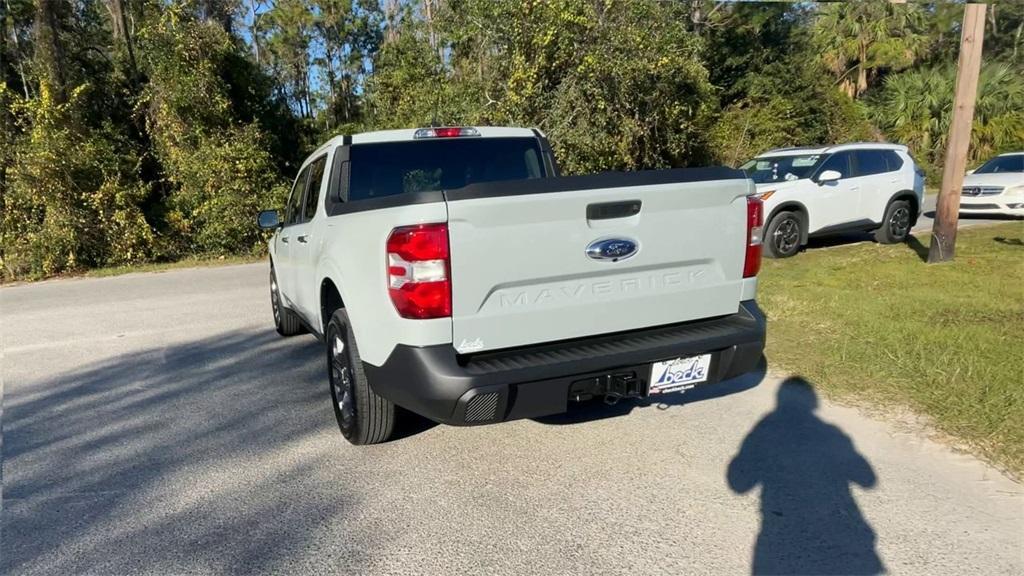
xmin=259 ymin=127 xmax=765 ymax=444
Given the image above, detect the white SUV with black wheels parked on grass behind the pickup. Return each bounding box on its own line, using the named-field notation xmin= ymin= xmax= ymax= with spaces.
xmin=741 ymin=143 xmax=925 ymax=258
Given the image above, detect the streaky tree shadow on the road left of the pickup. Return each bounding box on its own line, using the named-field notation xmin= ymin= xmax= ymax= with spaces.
xmin=0 ymin=330 xmax=376 ymax=574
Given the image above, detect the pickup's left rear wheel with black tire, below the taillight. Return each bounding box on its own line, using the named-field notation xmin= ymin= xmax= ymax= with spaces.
xmin=324 ymin=308 xmax=395 ymax=446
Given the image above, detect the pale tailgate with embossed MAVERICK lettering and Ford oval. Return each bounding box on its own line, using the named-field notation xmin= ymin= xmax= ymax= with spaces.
xmin=445 ymin=169 xmax=753 ymax=354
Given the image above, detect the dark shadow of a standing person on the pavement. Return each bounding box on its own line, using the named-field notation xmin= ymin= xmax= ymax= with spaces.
xmin=727 ymin=377 xmax=885 ymax=574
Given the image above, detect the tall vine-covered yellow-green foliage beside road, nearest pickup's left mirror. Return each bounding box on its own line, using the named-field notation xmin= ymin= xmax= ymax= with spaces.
xmin=140 ymin=9 xmax=283 ymax=257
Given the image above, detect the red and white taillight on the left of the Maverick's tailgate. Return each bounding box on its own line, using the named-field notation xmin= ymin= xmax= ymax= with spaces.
xmin=387 ymin=224 xmax=452 ymax=319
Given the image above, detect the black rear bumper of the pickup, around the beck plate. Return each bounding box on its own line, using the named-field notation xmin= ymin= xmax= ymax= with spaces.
xmin=364 ymin=300 xmax=765 ymax=424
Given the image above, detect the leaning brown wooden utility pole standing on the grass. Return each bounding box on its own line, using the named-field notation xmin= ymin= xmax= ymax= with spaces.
xmin=928 ymin=4 xmax=985 ymax=263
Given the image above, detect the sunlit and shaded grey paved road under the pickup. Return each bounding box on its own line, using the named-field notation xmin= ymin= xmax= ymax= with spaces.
xmin=0 ymin=263 xmax=1024 ymax=576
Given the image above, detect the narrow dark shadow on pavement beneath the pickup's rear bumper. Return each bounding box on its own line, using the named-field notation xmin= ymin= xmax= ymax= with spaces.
xmin=534 ymin=357 xmax=768 ymax=425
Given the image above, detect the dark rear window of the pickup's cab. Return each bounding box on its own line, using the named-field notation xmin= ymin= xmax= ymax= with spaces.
xmin=348 ymin=137 xmax=545 ymax=200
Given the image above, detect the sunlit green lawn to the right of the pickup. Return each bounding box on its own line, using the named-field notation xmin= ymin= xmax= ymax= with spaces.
xmin=759 ymin=222 xmax=1024 ymax=477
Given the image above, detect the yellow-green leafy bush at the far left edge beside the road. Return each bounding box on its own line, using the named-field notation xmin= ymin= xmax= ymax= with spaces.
xmin=0 ymin=85 xmax=153 ymax=279
